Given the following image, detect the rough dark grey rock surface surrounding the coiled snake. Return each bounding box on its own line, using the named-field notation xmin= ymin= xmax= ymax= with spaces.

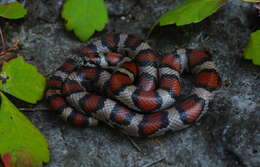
xmin=3 ymin=0 xmax=260 ymax=167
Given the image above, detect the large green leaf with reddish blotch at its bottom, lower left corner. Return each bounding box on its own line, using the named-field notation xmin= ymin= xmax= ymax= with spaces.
xmin=0 ymin=93 xmax=49 ymax=167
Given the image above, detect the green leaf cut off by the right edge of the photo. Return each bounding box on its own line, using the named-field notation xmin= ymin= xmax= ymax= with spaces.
xmin=244 ymin=30 xmax=260 ymax=65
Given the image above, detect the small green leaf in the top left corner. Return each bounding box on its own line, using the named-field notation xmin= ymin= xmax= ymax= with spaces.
xmin=0 ymin=2 xmax=27 ymax=19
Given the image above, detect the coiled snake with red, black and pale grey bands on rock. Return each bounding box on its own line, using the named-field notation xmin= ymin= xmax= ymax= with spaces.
xmin=46 ymin=34 xmax=221 ymax=137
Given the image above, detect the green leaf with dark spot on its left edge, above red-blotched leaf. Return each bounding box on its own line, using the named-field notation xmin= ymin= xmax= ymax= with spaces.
xmin=0 ymin=57 xmax=46 ymax=103
